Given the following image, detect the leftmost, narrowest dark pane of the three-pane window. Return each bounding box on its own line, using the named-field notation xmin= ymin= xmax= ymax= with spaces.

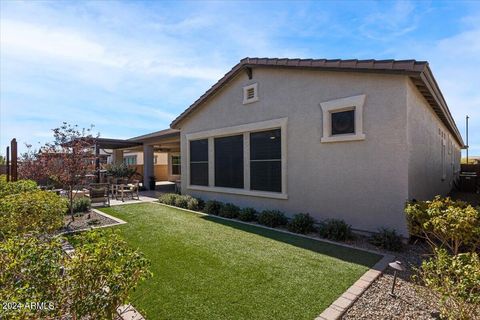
xmin=190 ymin=139 xmax=208 ymax=186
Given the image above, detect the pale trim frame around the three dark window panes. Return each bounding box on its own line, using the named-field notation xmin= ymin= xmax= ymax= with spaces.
xmin=185 ymin=118 xmax=288 ymax=199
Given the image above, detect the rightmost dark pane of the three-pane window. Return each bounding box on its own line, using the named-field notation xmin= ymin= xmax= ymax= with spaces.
xmin=250 ymin=129 xmax=282 ymax=192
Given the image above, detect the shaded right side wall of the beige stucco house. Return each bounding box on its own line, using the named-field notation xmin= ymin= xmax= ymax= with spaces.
xmin=407 ymin=80 xmax=461 ymax=200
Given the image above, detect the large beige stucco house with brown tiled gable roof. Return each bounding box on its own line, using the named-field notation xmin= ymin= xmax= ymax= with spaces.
xmin=171 ymin=58 xmax=464 ymax=235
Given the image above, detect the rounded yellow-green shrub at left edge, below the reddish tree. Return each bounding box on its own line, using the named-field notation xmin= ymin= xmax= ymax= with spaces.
xmin=0 ymin=190 xmax=67 ymax=239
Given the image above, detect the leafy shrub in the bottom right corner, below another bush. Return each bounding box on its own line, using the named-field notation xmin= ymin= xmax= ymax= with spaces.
xmin=417 ymin=249 xmax=480 ymax=320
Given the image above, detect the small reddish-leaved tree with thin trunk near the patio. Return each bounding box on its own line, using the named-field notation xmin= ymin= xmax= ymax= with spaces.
xmin=20 ymin=122 xmax=98 ymax=220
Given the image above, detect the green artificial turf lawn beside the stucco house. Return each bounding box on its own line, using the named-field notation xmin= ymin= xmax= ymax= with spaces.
xmin=102 ymin=203 xmax=380 ymax=320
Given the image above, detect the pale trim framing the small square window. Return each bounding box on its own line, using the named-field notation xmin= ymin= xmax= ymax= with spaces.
xmin=320 ymin=94 xmax=365 ymax=142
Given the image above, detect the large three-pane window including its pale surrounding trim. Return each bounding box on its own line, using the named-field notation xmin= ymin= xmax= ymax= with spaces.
xmin=185 ymin=118 xmax=288 ymax=199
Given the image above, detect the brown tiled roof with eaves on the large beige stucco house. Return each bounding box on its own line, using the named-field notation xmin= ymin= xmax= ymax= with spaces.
xmin=170 ymin=58 xmax=464 ymax=147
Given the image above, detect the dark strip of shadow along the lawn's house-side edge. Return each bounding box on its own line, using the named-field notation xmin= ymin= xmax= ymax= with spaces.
xmin=201 ymin=216 xmax=382 ymax=268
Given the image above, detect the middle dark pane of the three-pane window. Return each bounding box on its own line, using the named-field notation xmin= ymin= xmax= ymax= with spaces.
xmin=215 ymin=135 xmax=243 ymax=188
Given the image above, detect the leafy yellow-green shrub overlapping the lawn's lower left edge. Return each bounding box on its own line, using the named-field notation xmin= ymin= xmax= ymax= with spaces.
xmin=66 ymin=231 xmax=151 ymax=319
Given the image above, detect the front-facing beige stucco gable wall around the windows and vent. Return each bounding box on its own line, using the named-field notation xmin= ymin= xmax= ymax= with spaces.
xmin=181 ymin=68 xmax=408 ymax=235
